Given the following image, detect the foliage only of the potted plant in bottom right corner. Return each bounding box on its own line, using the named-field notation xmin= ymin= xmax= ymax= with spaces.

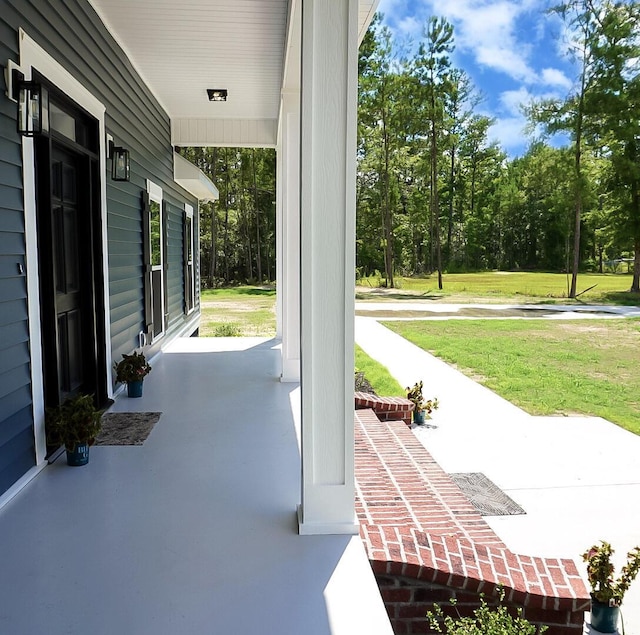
xmin=582 ymin=540 xmax=640 ymax=606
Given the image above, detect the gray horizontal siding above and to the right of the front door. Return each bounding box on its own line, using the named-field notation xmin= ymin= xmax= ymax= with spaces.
xmin=7 ymin=0 xmax=196 ymax=359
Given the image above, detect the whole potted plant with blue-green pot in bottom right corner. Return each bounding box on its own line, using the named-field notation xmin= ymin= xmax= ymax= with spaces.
xmin=582 ymin=540 xmax=640 ymax=633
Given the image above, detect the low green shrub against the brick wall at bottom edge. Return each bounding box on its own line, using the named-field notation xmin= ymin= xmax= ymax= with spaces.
xmin=427 ymin=590 xmax=547 ymax=635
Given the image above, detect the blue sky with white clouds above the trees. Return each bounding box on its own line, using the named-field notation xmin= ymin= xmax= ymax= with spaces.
xmin=378 ymin=0 xmax=576 ymax=157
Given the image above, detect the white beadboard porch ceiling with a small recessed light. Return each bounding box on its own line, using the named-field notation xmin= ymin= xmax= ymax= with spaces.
xmin=90 ymin=0 xmax=379 ymax=145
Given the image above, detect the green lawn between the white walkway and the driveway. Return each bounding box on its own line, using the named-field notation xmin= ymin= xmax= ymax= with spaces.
xmin=385 ymin=319 xmax=640 ymax=434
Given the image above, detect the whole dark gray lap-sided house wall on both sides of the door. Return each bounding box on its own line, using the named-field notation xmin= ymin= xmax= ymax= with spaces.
xmin=0 ymin=0 xmax=199 ymax=496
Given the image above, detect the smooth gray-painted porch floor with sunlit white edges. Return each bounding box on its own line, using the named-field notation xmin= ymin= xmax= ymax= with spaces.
xmin=0 ymin=338 xmax=391 ymax=635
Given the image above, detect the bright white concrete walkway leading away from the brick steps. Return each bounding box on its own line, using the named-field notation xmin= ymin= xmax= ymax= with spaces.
xmin=356 ymin=317 xmax=640 ymax=635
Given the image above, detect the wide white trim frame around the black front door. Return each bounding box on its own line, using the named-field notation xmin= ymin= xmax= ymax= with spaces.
xmin=18 ymin=29 xmax=113 ymax=465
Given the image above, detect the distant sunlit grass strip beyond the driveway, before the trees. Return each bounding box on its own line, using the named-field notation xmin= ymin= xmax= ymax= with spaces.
xmin=358 ymin=271 xmax=640 ymax=305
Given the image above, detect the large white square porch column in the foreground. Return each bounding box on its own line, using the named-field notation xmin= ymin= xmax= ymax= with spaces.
xmin=299 ymin=0 xmax=358 ymax=534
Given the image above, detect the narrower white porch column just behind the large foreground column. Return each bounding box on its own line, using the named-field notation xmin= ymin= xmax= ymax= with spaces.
xmin=278 ymin=91 xmax=300 ymax=382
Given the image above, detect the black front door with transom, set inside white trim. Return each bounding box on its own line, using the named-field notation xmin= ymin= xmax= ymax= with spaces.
xmin=35 ymin=90 xmax=107 ymax=428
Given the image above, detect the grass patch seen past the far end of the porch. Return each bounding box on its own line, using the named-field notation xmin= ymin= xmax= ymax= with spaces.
xmin=200 ymin=286 xmax=276 ymax=337
